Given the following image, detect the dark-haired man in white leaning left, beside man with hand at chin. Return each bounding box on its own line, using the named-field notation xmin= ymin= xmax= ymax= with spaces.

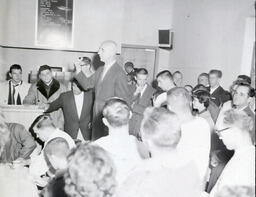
xmin=153 ymin=70 xmax=176 ymax=107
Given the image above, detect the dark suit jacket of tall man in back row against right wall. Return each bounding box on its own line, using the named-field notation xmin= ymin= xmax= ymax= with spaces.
xmin=211 ymin=86 xmax=231 ymax=107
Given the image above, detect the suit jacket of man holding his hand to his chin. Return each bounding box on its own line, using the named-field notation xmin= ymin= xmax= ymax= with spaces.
xmin=129 ymin=85 xmax=155 ymax=137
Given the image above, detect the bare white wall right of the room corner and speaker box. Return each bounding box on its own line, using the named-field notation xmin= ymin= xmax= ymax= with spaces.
xmin=170 ymin=0 xmax=255 ymax=88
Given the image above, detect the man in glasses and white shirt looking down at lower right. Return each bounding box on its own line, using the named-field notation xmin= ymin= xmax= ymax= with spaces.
xmin=210 ymin=109 xmax=255 ymax=197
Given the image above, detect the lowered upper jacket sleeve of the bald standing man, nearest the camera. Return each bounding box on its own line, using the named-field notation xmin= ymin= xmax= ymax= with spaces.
xmin=114 ymin=73 xmax=132 ymax=105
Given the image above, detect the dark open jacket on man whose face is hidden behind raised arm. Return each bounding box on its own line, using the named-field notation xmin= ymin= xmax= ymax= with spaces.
xmin=46 ymin=90 xmax=93 ymax=140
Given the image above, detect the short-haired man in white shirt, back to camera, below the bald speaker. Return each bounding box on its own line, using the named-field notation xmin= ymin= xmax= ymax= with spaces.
xmin=94 ymin=98 xmax=142 ymax=183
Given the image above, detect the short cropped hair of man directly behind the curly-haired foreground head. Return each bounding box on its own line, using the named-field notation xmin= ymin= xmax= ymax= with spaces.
xmin=44 ymin=137 xmax=70 ymax=159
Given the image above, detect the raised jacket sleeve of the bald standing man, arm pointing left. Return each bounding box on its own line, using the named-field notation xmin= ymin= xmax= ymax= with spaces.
xmin=75 ymin=70 xmax=99 ymax=90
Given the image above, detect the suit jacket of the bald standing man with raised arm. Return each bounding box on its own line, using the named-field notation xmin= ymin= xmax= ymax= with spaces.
xmin=75 ymin=63 xmax=131 ymax=140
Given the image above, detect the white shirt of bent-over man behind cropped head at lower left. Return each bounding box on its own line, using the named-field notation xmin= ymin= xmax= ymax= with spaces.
xmin=29 ymin=129 xmax=76 ymax=177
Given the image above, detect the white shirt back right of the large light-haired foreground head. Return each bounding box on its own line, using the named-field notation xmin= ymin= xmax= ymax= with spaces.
xmin=177 ymin=117 xmax=211 ymax=187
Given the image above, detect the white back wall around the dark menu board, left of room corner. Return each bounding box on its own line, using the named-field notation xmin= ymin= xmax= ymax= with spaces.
xmin=0 ymin=0 xmax=174 ymax=80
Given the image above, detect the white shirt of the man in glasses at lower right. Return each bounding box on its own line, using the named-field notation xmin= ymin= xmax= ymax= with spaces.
xmin=210 ymin=145 xmax=255 ymax=197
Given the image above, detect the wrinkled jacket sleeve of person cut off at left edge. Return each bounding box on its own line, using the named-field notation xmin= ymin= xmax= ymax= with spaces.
xmin=15 ymin=124 xmax=36 ymax=159
